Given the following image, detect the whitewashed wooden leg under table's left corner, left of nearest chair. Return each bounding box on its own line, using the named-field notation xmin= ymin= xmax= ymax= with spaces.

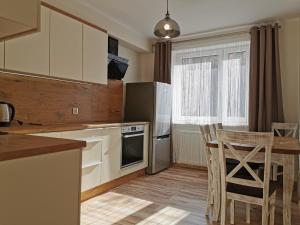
xmin=211 ymin=149 xmax=221 ymax=222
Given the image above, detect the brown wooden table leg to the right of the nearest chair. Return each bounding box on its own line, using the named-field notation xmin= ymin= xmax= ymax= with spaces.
xmin=283 ymin=155 xmax=295 ymax=225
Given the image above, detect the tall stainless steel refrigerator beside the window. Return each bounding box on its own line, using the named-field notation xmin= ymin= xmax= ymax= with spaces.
xmin=124 ymin=82 xmax=172 ymax=174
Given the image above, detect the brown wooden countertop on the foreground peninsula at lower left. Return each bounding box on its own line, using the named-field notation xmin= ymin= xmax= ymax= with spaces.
xmin=0 ymin=134 xmax=86 ymax=161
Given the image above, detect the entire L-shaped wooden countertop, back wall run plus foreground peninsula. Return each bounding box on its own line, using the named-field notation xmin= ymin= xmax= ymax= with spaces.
xmin=0 ymin=122 xmax=148 ymax=161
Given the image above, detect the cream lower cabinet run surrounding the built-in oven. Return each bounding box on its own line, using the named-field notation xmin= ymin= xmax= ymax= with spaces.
xmin=30 ymin=124 xmax=149 ymax=191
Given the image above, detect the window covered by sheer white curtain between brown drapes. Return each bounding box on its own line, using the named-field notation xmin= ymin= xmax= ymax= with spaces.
xmin=172 ymin=41 xmax=250 ymax=126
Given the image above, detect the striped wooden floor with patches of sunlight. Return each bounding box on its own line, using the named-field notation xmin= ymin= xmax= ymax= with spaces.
xmin=81 ymin=168 xmax=300 ymax=225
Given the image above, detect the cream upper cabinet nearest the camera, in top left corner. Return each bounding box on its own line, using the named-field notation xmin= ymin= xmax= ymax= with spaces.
xmin=0 ymin=0 xmax=40 ymax=39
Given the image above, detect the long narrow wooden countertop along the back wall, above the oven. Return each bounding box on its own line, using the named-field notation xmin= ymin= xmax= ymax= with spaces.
xmin=0 ymin=122 xmax=149 ymax=134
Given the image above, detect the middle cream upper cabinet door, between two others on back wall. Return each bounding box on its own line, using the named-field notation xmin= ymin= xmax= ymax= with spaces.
xmin=50 ymin=11 xmax=82 ymax=80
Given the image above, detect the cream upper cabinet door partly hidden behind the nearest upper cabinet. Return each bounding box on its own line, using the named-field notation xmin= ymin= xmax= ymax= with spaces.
xmin=5 ymin=7 xmax=50 ymax=75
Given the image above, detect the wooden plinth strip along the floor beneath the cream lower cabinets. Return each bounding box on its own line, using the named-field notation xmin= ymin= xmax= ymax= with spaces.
xmin=81 ymin=169 xmax=145 ymax=202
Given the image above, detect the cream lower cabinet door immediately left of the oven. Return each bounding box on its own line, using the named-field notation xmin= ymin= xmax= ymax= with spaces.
xmin=101 ymin=127 xmax=122 ymax=184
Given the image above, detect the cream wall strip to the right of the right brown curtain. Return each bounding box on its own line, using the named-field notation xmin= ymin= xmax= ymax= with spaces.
xmin=279 ymin=17 xmax=300 ymax=122
